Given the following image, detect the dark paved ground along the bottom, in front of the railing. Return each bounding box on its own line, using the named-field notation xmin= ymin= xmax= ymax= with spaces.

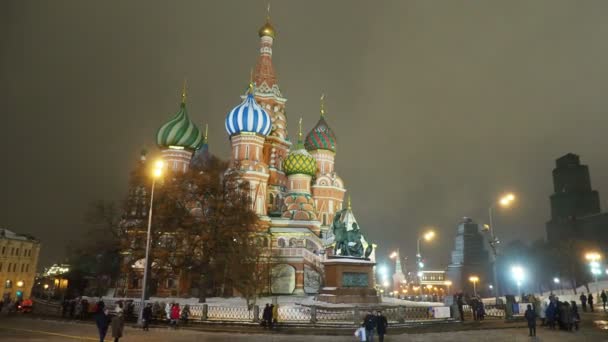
xmin=0 ymin=316 xmax=608 ymax=342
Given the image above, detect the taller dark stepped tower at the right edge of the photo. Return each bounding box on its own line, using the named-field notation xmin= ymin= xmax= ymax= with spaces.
xmin=546 ymin=153 xmax=608 ymax=245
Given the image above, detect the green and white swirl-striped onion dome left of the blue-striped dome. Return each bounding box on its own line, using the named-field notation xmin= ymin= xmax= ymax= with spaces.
xmin=156 ymin=101 xmax=203 ymax=150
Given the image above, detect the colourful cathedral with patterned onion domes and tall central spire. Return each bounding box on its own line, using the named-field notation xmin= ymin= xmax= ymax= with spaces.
xmin=119 ymin=13 xmax=374 ymax=295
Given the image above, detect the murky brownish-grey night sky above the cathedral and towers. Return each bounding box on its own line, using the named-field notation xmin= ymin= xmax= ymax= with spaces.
xmin=0 ymin=0 xmax=608 ymax=272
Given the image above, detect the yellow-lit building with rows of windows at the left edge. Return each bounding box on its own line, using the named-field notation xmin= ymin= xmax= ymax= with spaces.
xmin=0 ymin=229 xmax=40 ymax=300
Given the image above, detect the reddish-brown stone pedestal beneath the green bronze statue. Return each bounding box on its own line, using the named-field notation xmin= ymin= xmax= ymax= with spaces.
xmin=318 ymin=256 xmax=380 ymax=304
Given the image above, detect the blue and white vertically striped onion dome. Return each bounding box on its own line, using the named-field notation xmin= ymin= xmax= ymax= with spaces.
xmin=226 ymin=92 xmax=272 ymax=136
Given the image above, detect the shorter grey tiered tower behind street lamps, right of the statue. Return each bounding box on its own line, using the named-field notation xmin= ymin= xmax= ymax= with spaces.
xmin=444 ymin=217 xmax=493 ymax=294
